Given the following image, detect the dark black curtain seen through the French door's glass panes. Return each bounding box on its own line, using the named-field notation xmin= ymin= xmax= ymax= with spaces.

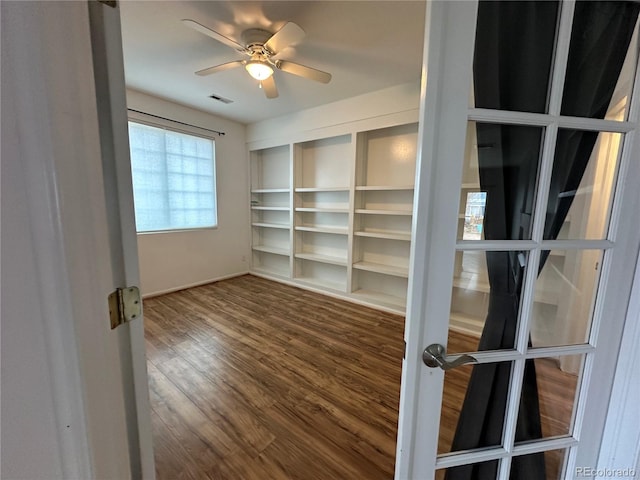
xmin=446 ymin=1 xmax=640 ymax=480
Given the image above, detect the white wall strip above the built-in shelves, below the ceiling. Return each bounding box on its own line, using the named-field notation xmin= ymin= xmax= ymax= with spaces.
xmin=247 ymin=79 xmax=420 ymax=148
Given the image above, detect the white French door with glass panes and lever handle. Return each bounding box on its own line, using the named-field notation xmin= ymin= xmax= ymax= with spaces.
xmin=396 ymin=1 xmax=640 ymax=480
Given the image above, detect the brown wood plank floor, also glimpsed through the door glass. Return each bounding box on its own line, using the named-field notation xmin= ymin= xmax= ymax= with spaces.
xmin=144 ymin=275 xmax=575 ymax=480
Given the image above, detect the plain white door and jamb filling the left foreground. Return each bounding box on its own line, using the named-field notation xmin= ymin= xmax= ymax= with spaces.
xmin=2 ymin=1 xmax=154 ymax=479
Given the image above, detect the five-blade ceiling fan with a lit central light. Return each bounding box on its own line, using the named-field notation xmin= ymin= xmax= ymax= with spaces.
xmin=182 ymin=19 xmax=331 ymax=98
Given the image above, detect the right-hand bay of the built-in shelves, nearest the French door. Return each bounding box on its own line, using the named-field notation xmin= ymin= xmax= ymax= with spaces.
xmin=352 ymin=124 xmax=418 ymax=310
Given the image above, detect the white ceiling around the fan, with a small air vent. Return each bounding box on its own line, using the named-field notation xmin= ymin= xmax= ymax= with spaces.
xmin=120 ymin=0 xmax=425 ymax=123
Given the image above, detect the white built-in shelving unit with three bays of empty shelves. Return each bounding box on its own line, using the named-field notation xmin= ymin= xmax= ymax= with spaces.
xmin=251 ymin=124 xmax=417 ymax=313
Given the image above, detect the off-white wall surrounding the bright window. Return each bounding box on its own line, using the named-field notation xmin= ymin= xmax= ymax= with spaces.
xmin=127 ymin=90 xmax=250 ymax=295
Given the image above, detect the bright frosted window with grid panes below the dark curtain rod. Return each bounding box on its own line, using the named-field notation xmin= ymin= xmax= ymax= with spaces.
xmin=129 ymin=122 xmax=218 ymax=232
